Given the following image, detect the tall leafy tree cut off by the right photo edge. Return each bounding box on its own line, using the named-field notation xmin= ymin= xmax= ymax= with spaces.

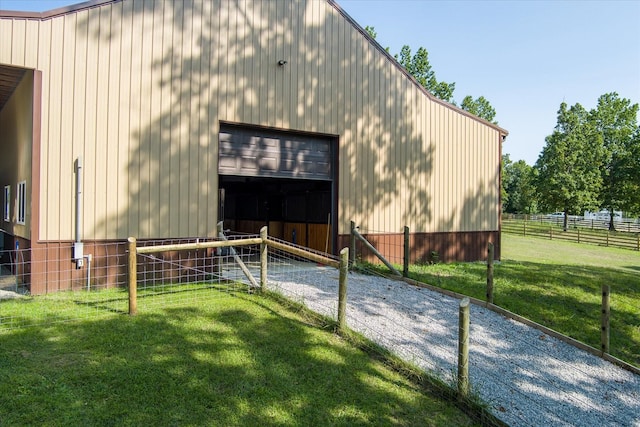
xmin=590 ymin=92 xmax=640 ymax=230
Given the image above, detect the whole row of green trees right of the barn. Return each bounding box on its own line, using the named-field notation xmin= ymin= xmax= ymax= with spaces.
xmin=502 ymin=92 xmax=640 ymax=230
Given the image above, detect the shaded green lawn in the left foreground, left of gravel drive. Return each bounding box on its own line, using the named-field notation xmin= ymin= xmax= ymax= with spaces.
xmin=0 ymin=290 xmax=480 ymax=426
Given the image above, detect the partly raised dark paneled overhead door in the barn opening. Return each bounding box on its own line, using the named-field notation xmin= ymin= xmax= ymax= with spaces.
xmin=218 ymin=125 xmax=333 ymax=181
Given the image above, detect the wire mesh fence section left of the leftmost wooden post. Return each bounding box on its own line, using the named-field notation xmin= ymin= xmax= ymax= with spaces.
xmin=0 ymin=243 xmax=127 ymax=331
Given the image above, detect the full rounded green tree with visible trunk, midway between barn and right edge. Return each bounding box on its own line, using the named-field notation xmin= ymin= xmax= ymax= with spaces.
xmin=535 ymin=102 xmax=603 ymax=231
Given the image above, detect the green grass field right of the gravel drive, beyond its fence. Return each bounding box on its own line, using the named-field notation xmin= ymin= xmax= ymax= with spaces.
xmin=410 ymin=233 xmax=640 ymax=366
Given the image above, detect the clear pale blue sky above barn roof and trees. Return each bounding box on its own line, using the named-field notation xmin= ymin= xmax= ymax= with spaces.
xmin=0 ymin=0 xmax=640 ymax=165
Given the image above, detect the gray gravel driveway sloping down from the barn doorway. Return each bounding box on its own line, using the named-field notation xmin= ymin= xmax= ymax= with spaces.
xmin=269 ymin=266 xmax=640 ymax=427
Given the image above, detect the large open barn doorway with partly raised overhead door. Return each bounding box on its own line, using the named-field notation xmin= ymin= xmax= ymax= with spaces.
xmin=218 ymin=125 xmax=337 ymax=253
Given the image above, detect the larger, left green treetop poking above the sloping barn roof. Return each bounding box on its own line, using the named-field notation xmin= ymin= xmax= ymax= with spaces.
xmin=395 ymin=45 xmax=456 ymax=102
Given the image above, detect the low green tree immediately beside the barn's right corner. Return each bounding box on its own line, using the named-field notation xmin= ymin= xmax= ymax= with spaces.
xmin=502 ymin=154 xmax=537 ymax=214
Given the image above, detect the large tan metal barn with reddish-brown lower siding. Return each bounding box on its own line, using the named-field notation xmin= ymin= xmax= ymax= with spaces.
xmin=0 ymin=0 xmax=507 ymax=294
